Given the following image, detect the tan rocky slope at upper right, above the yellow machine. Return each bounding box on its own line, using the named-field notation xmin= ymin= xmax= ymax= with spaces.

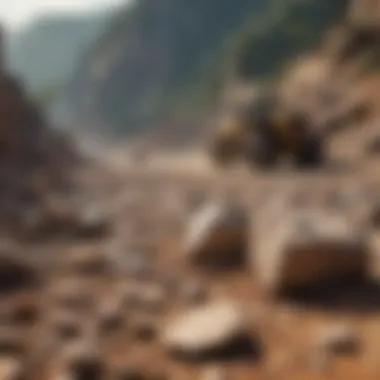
xmin=280 ymin=0 xmax=380 ymax=139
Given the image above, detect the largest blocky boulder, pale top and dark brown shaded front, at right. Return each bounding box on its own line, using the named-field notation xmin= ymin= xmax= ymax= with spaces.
xmin=251 ymin=208 xmax=370 ymax=293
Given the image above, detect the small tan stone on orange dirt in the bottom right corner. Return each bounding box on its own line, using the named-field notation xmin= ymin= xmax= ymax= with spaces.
xmin=316 ymin=324 xmax=361 ymax=355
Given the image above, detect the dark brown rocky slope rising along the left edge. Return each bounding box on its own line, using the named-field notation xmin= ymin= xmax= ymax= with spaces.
xmin=0 ymin=24 xmax=79 ymax=238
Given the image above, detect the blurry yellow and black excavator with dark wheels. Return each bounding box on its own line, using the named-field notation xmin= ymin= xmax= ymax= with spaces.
xmin=210 ymin=92 xmax=324 ymax=168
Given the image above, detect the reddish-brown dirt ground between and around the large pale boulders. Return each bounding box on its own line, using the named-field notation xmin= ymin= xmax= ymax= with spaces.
xmin=0 ymin=126 xmax=380 ymax=380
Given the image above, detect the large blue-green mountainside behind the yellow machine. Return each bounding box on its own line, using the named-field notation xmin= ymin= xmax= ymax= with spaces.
xmin=54 ymin=0 xmax=347 ymax=135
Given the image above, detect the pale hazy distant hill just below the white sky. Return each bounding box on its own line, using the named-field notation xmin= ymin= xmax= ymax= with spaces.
xmin=8 ymin=12 xmax=112 ymax=93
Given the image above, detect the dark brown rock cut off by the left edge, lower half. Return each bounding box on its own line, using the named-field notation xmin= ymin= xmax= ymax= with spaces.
xmin=0 ymin=252 xmax=41 ymax=293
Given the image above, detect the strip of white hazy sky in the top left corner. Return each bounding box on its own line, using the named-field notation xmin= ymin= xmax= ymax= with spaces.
xmin=0 ymin=0 xmax=128 ymax=29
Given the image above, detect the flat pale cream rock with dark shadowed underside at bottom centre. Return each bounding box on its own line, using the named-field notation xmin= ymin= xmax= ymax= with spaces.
xmin=162 ymin=301 xmax=259 ymax=361
